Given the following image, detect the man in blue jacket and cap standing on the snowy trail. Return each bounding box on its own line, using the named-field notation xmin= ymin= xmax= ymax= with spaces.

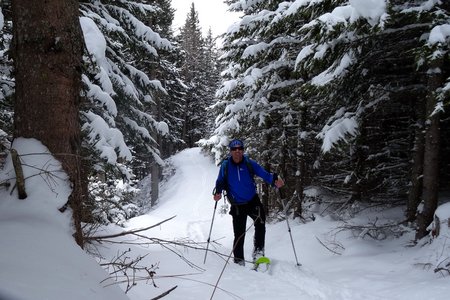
xmin=213 ymin=139 xmax=284 ymax=265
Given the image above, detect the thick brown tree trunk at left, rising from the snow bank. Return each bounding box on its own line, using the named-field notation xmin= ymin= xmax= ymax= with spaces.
xmin=12 ymin=0 xmax=87 ymax=247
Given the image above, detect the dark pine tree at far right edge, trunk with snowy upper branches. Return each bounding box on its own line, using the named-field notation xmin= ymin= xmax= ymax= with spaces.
xmin=407 ymin=2 xmax=450 ymax=239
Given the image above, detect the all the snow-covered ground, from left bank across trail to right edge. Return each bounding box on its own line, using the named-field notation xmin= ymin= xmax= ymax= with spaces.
xmin=0 ymin=141 xmax=450 ymax=300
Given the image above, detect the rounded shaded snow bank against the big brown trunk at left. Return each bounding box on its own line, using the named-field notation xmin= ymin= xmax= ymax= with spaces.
xmin=0 ymin=138 xmax=128 ymax=300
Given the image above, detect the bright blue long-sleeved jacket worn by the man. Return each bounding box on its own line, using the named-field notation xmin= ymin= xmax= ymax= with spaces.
xmin=215 ymin=156 xmax=274 ymax=205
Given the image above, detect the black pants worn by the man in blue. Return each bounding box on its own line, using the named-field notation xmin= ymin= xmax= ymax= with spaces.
xmin=230 ymin=195 xmax=266 ymax=261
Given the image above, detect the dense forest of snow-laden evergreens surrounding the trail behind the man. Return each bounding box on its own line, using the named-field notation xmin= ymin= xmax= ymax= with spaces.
xmin=0 ymin=0 xmax=450 ymax=246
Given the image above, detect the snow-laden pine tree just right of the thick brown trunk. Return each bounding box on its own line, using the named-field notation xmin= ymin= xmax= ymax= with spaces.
xmin=80 ymin=1 xmax=183 ymax=214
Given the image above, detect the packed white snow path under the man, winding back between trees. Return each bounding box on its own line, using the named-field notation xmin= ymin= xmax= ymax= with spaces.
xmin=117 ymin=148 xmax=442 ymax=300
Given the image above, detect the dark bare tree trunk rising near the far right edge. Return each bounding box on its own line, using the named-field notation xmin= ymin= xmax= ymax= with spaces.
xmin=416 ymin=59 xmax=443 ymax=239
